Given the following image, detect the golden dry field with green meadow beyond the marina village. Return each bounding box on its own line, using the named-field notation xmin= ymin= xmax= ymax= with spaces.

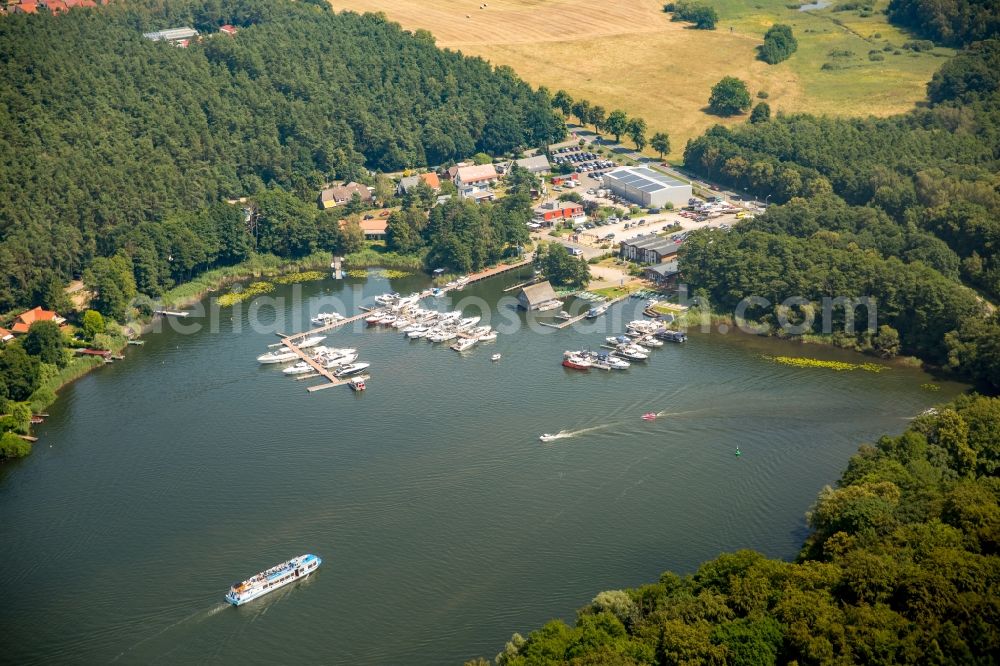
xmin=335 ymin=0 xmax=952 ymax=159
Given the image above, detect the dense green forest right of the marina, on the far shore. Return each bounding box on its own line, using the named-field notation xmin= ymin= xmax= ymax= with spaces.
xmin=681 ymin=40 xmax=1000 ymax=391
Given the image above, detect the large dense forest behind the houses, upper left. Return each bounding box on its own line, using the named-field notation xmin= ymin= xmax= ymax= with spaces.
xmin=0 ymin=0 xmax=564 ymax=312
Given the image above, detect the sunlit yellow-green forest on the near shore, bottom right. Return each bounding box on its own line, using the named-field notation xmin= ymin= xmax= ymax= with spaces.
xmin=474 ymin=395 xmax=1000 ymax=666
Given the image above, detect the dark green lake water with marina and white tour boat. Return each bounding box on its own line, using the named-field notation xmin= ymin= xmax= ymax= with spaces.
xmin=0 ymin=268 xmax=963 ymax=664
